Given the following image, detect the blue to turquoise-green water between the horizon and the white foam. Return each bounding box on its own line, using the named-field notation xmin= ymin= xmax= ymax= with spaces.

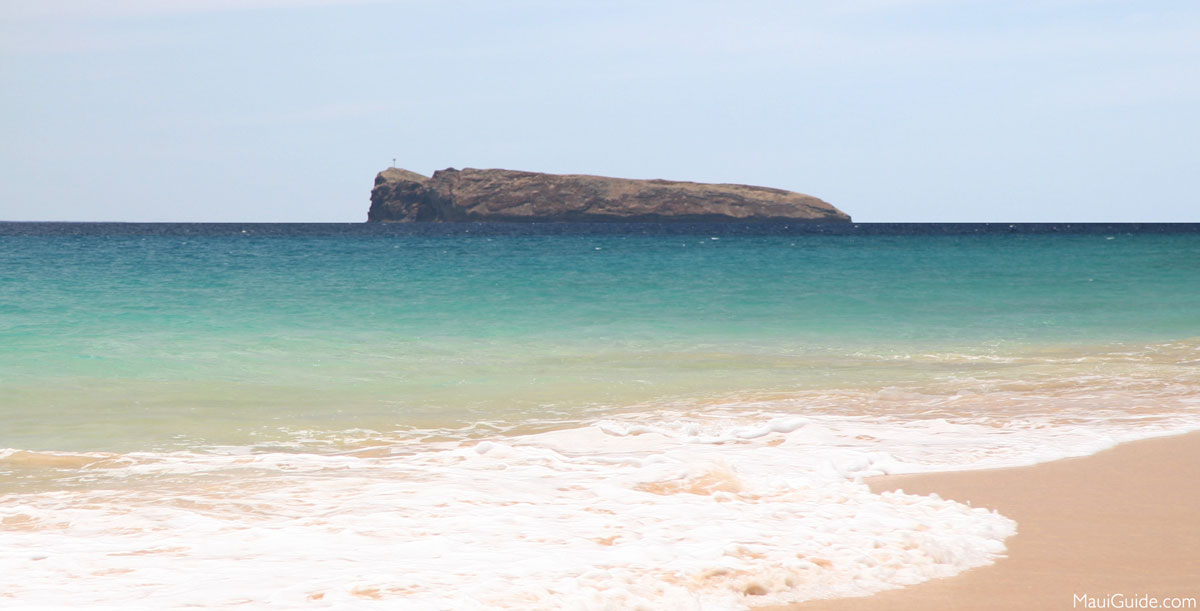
xmin=0 ymin=226 xmax=1200 ymax=450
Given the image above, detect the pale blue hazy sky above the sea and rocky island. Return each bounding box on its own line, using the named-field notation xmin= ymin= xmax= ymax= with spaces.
xmin=0 ymin=0 xmax=1200 ymax=222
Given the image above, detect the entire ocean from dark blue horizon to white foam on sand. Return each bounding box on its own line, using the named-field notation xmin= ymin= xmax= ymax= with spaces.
xmin=0 ymin=223 xmax=1200 ymax=609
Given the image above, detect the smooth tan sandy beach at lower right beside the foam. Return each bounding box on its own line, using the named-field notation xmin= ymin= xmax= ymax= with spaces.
xmin=768 ymin=432 xmax=1200 ymax=611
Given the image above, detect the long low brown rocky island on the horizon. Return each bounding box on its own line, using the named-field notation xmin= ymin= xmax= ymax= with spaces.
xmin=367 ymin=168 xmax=850 ymax=222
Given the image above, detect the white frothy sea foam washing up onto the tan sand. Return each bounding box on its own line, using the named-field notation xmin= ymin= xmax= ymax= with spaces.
xmin=7 ymin=402 xmax=1194 ymax=609
